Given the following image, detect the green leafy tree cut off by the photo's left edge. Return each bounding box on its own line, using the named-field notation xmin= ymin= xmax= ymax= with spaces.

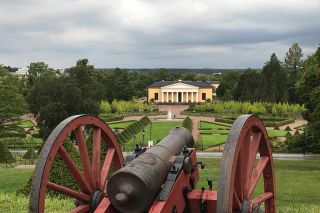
xmin=0 ymin=66 xmax=27 ymax=125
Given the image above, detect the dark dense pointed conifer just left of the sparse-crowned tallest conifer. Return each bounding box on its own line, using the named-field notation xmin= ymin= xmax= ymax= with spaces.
xmin=259 ymin=53 xmax=288 ymax=102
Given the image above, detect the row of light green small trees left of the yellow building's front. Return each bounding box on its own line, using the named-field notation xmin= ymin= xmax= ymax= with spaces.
xmin=100 ymin=100 xmax=154 ymax=114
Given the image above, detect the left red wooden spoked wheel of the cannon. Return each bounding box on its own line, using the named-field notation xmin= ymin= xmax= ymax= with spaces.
xmin=29 ymin=115 xmax=123 ymax=213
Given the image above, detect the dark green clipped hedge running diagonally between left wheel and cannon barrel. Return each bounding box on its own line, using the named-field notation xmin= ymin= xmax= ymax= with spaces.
xmin=118 ymin=116 xmax=151 ymax=143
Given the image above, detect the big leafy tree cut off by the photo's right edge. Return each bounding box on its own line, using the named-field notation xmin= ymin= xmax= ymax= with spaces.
xmin=297 ymin=47 xmax=320 ymax=153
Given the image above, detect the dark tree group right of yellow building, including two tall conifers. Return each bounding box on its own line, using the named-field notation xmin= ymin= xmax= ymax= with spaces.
xmin=217 ymin=43 xmax=303 ymax=103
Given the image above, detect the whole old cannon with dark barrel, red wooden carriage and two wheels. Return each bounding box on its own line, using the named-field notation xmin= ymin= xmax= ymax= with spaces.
xmin=29 ymin=115 xmax=276 ymax=213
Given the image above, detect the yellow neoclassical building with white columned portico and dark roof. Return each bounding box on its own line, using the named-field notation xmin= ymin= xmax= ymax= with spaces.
xmin=148 ymin=80 xmax=219 ymax=103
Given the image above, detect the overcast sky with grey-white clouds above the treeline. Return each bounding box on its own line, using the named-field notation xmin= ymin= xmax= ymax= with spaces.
xmin=0 ymin=0 xmax=320 ymax=68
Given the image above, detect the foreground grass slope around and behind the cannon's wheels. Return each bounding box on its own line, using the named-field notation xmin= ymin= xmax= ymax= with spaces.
xmin=0 ymin=158 xmax=320 ymax=213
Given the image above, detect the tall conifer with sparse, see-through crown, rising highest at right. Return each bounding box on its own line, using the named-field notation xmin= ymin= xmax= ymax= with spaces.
xmin=284 ymin=43 xmax=303 ymax=102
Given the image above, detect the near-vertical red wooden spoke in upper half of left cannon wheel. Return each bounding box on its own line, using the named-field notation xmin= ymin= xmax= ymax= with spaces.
xmin=92 ymin=128 xmax=101 ymax=187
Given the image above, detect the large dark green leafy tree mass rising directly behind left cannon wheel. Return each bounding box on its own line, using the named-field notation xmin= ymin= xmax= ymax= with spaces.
xmin=27 ymin=59 xmax=102 ymax=139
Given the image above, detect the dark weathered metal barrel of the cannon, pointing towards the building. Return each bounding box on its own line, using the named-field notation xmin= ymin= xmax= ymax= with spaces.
xmin=107 ymin=127 xmax=194 ymax=213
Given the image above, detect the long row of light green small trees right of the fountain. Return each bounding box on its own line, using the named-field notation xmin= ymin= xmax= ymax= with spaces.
xmin=188 ymin=101 xmax=305 ymax=117
